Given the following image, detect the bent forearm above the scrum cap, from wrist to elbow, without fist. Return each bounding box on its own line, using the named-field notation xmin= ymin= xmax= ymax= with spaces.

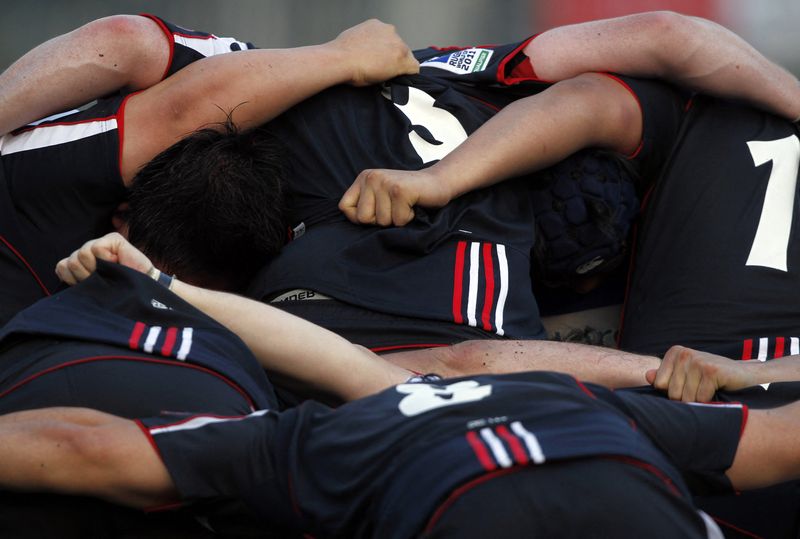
xmin=429 ymin=75 xmax=642 ymax=199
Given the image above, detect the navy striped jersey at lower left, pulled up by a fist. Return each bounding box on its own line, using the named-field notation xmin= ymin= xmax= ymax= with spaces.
xmin=0 ymin=261 xmax=276 ymax=411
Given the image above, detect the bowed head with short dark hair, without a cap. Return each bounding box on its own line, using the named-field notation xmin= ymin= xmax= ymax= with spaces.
xmin=128 ymin=118 xmax=287 ymax=290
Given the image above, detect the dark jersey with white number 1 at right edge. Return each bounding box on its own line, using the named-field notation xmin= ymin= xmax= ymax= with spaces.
xmin=621 ymin=98 xmax=800 ymax=361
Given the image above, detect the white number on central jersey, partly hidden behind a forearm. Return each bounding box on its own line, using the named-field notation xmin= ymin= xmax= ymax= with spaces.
xmin=383 ymin=87 xmax=467 ymax=164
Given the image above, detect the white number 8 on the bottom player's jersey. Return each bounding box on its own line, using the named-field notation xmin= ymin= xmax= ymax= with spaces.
xmin=397 ymin=380 xmax=492 ymax=417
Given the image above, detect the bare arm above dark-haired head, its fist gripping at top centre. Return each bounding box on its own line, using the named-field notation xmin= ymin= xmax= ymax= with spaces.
xmin=121 ymin=20 xmax=419 ymax=182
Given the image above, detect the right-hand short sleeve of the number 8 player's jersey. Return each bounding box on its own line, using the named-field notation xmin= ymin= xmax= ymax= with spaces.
xmin=616 ymin=391 xmax=747 ymax=492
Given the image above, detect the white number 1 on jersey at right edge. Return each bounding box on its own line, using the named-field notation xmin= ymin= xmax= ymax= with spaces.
xmin=745 ymin=135 xmax=800 ymax=271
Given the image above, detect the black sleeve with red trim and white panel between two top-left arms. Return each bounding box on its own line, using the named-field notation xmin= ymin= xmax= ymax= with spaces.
xmin=142 ymin=13 xmax=256 ymax=78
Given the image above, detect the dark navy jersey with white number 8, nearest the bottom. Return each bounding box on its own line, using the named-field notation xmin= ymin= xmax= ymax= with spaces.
xmin=141 ymin=373 xmax=745 ymax=538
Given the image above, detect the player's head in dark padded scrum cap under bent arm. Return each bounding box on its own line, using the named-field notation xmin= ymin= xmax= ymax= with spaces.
xmin=533 ymin=150 xmax=639 ymax=292
